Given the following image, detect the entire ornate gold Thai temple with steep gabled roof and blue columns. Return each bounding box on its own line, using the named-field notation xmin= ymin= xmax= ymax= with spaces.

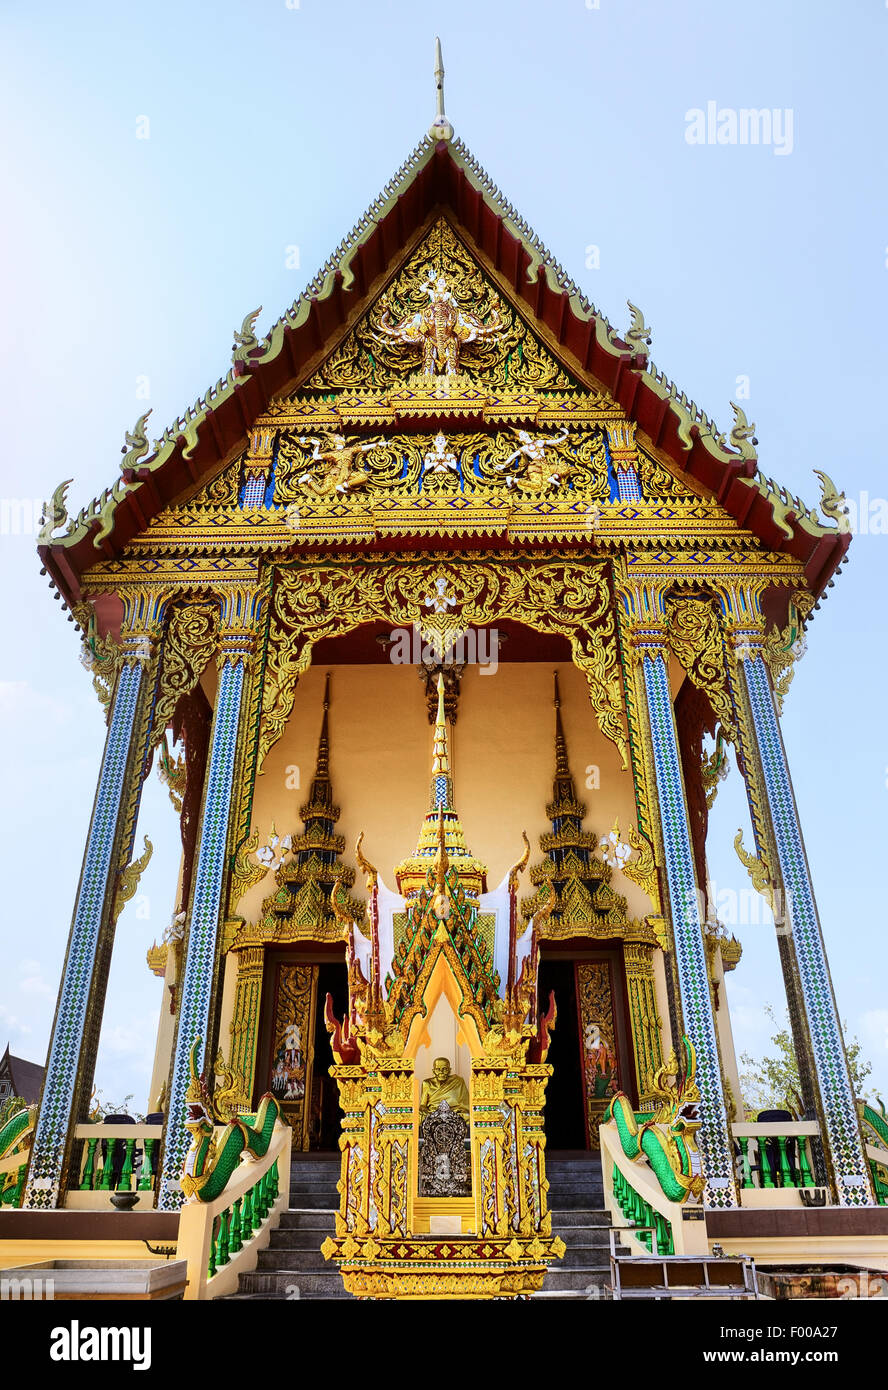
xmin=0 ymin=43 xmax=888 ymax=1298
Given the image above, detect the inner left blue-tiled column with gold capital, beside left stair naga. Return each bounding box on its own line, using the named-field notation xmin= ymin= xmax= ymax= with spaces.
xmin=157 ymin=591 xmax=261 ymax=1211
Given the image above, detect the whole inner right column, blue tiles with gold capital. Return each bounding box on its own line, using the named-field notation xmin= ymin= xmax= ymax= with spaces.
xmin=621 ymin=585 xmax=737 ymax=1208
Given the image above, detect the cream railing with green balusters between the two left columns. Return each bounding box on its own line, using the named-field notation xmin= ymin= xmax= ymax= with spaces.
xmin=64 ymin=1120 xmax=161 ymax=1211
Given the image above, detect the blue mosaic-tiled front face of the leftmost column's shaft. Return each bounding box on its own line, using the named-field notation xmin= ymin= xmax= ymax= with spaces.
xmin=22 ymin=664 xmax=143 ymax=1209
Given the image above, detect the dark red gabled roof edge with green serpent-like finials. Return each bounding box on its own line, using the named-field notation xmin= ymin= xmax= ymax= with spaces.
xmin=38 ymin=136 xmax=850 ymax=603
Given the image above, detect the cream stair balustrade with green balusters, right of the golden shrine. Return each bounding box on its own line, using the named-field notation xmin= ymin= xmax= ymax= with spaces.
xmin=599 ymin=1120 xmax=709 ymax=1255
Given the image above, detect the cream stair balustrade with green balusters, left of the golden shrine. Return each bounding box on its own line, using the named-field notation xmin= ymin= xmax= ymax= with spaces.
xmin=176 ymin=1120 xmax=293 ymax=1300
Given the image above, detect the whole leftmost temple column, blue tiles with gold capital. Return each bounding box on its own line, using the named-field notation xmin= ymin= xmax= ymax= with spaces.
xmin=22 ymin=594 xmax=160 ymax=1209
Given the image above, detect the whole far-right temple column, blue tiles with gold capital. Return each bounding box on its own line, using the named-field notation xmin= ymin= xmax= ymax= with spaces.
xmin=724 ymin=591 xmax=874 ymax=1207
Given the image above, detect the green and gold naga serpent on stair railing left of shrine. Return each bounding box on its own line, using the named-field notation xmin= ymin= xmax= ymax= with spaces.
xmin=182 ymin=1038 xmax=281 ymax=1202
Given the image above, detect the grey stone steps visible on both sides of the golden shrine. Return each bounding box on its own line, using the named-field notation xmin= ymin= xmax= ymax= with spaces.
xmin=231 ymin=1152 xmax=610 ymax=1300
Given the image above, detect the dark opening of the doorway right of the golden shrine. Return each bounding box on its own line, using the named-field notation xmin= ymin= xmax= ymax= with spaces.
xmin=539 ymin=958 xmax=586 ymax=1150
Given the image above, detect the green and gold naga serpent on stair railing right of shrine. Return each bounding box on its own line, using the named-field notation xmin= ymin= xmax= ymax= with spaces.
xmin=603 ymin=1037 xmax=706 ymax=1202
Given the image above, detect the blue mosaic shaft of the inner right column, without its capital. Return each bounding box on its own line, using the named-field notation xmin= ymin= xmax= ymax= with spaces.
xmin=642 ymin=655 xmax=737 ymax=1207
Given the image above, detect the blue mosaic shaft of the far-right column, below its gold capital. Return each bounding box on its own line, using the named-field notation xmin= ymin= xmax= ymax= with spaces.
xmin=737 ymin=631 xmax=874 ymax=1207
